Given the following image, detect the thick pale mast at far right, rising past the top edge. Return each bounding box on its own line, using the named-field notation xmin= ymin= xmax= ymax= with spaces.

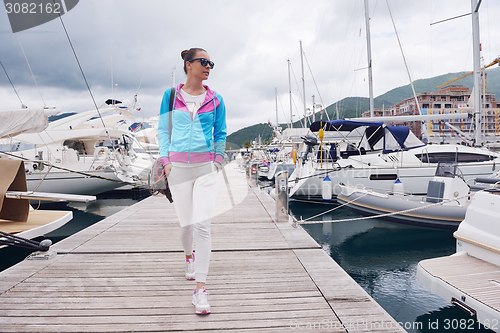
xmin=471 ymin=0 xmax=483 ymax=146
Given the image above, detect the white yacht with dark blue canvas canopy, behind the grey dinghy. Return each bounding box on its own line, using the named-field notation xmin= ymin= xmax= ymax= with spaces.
xmin=289 ymin=119 xmax=500 ymax=200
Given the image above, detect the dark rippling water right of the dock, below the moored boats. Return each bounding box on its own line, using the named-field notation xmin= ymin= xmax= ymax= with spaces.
xmin=290 ymin=201 xmax=492 ymax=333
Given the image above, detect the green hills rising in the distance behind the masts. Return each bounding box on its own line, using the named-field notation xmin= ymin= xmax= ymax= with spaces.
xmin=227 ymin=67 xmax=500 ymax=147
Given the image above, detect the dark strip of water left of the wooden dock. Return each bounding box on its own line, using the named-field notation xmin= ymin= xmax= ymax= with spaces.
xmin=0 ymin=191 xmax=144 ymax=272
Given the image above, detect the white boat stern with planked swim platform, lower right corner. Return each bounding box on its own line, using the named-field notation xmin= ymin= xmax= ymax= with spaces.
xmin=417 ymin=187 xmax=500 ymax=332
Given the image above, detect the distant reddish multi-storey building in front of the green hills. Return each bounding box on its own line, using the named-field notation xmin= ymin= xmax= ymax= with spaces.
xmin=363 ymin=85 xmax=500 ymax=142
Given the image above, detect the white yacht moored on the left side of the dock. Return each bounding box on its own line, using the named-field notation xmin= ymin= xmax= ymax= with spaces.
xmin=3 ymin=100 xmax=153 ymax=195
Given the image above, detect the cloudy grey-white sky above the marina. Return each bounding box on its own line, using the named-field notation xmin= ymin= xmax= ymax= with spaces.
xmin=0 ymin=0 xmax=500 ymax=134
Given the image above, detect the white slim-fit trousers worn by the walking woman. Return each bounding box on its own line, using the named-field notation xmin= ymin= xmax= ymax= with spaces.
xmin=168 ymin=162 xmax=219 ymax=282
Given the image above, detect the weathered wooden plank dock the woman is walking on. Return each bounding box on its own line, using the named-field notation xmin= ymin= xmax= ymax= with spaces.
xmin=0 ymin=163 xmax=405 ymax=333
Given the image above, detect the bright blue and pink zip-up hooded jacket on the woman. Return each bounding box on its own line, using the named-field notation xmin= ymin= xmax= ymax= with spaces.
xmin=158 ymin=84 xmax=227 ymax=165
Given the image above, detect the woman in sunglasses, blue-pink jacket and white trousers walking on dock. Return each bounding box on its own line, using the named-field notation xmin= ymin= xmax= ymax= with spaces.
xmin=158 ymin=48 xmax=227 ymax=314
